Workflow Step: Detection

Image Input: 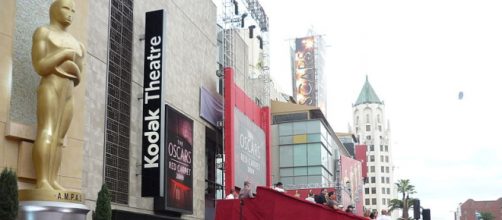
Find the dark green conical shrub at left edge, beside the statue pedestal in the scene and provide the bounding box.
[0,169,19,220]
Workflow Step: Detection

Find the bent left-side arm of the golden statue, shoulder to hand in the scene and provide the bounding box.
[31,27,76,76]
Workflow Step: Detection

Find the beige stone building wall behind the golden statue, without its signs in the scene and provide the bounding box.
[0,0,226,219]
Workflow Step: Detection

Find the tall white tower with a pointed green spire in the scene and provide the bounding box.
[352,76,396,212]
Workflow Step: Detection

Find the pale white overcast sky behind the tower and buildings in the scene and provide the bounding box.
[260,0,502,220]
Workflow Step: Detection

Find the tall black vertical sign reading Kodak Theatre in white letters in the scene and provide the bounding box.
[141,10,165,197]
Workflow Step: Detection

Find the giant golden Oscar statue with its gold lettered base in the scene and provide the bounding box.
[20,0,85,202]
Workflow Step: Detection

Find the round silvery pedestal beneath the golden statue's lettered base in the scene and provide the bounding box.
[18,201,89,220]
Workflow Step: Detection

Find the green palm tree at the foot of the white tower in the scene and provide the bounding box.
[389,179,416,219]
